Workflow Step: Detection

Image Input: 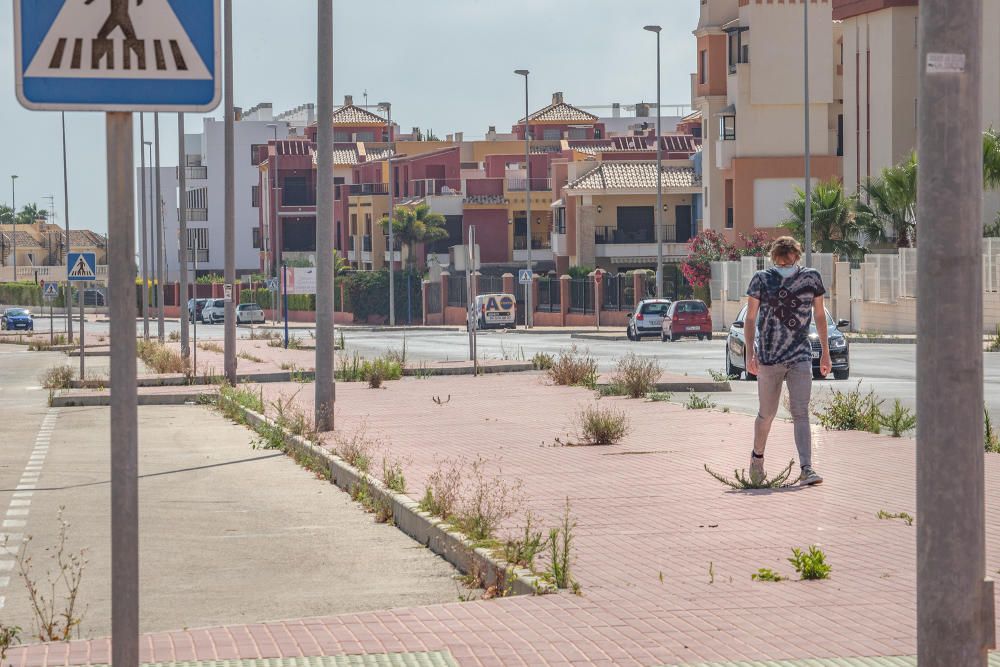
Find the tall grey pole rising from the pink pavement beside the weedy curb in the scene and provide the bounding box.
[315,0,338,432]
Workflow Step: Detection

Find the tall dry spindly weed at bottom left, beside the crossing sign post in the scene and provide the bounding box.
[16,507,88,642]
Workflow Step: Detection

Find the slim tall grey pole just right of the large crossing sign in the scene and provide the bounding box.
[223,0,236,386]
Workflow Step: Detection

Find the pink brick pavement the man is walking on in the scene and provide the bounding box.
[12,374,1000,665]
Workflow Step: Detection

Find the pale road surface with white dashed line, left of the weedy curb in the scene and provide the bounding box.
[0,345,459,641]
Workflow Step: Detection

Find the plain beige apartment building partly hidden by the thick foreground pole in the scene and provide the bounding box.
[833,0,1000,221]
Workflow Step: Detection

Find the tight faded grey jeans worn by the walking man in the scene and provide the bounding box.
[753,361,812,467]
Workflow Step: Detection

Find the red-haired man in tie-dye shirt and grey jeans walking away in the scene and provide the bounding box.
[743,236,833,486]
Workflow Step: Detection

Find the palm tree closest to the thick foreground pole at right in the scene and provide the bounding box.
[857,153,917,248]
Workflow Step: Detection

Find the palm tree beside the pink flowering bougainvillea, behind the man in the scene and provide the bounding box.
[780,178,866,259]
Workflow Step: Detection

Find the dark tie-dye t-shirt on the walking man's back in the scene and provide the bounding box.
[747,267,826,366]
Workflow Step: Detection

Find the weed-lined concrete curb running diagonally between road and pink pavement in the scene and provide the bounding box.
[223,396,556,595]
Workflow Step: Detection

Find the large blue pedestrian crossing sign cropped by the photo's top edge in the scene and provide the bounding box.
[14,0,222,111]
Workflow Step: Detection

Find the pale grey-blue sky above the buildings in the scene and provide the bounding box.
[0,0,698,232]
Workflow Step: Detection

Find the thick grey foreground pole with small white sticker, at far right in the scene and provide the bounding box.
[917,0,996,667]
